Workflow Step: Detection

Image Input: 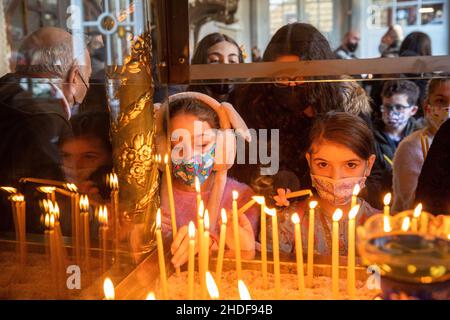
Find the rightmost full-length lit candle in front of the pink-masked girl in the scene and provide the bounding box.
[347,205,360,299]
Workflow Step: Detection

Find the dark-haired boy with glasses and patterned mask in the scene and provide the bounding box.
[374,80,420,201]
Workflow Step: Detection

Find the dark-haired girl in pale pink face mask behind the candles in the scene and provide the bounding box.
[268,112,378,255]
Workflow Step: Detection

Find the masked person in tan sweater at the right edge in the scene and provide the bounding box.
[393,74,450,211]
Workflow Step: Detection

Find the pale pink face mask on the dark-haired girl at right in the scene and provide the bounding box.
[311,174,367,206]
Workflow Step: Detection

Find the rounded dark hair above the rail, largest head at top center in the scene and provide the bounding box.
[263,22,334,62]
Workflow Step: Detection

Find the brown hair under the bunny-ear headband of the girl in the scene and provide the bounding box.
[163,99,220,132]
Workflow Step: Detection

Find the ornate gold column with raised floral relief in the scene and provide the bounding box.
[103,1,159,254]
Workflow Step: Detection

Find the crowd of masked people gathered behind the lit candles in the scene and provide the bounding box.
[0,23,450,266]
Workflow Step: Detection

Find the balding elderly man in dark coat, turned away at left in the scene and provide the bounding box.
[0,27,91,232]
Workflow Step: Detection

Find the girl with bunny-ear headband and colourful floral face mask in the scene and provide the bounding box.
[156,92,259,267]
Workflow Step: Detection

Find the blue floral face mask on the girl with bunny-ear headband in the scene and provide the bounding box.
[172,144,216,187]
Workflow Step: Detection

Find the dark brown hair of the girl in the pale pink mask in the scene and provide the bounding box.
[308,111,375,160]
